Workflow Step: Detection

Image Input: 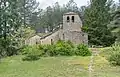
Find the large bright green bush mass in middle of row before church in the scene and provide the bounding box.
[39,41,73,56]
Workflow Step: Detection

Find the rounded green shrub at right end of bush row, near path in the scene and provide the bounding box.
[75,44,92,56]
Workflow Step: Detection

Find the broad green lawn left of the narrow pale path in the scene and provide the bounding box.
[0,56,89,77]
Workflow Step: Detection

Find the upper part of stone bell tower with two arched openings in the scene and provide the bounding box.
[63,12,82,31]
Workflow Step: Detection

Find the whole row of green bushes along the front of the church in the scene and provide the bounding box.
[22,40,91,57]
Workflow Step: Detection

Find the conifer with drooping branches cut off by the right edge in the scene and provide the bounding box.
[108,0,120,42]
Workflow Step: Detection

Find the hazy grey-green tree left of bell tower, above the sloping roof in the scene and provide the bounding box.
[36,2,63,32]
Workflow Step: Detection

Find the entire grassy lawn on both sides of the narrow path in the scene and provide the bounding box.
[0,49,120,77]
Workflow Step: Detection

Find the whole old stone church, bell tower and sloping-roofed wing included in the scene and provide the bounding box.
[25,12,88,45]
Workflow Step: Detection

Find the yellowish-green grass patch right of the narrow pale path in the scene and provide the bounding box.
[93,56,120,77]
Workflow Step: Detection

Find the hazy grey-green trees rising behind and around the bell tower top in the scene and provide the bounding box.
[35,0,84,32]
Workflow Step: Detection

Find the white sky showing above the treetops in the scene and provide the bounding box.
[37,0,118,9]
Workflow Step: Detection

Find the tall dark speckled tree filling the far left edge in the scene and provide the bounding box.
[0,0,21,56]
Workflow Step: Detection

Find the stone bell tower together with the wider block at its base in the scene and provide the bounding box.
[60,12,88,44]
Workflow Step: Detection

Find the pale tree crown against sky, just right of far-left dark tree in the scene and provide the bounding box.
[18,0,39,26]
